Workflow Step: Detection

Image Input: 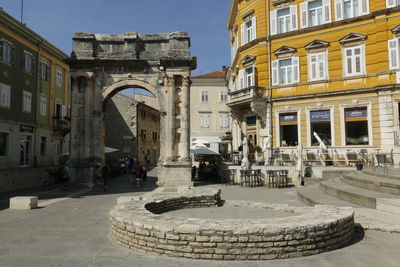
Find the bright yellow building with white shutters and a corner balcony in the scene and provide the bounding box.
[228,0,400,162]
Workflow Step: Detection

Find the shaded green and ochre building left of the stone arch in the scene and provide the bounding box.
[0,10,71,192]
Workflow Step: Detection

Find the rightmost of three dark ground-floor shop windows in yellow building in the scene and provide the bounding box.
[345,108,369,145]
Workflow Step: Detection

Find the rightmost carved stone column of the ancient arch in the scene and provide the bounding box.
[179,76,190,161]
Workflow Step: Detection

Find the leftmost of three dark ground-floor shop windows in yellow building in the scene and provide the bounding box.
[279,113,299,146]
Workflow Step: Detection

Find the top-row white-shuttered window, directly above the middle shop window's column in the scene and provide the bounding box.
[300,0,331,28]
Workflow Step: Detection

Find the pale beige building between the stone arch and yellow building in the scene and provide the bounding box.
[190,71,231,157]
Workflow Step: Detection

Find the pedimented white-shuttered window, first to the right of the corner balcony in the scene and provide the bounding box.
[272,57,300,85]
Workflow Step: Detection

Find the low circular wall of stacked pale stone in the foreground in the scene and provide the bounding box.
[110,188,354,260]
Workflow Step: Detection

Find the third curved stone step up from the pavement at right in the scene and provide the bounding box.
[341,172,400,196]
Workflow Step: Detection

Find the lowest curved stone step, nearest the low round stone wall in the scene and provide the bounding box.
[297,184,362,208]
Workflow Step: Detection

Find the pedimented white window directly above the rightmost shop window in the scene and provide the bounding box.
[343,45,365,77]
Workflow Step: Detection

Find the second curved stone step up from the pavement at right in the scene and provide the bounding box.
[320,178,396,209]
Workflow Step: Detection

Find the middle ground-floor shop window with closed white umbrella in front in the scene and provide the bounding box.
[310,110,332,146]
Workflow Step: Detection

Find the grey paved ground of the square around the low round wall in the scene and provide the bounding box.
[0,169,400,267]
